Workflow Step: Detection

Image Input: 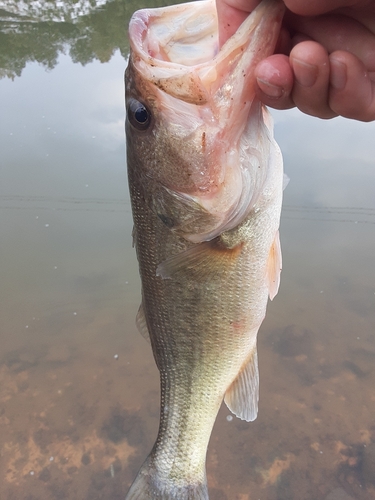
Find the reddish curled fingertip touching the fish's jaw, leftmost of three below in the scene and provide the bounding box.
[255,54,294,109]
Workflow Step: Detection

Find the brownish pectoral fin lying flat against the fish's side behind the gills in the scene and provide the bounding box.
[156,237,243,279]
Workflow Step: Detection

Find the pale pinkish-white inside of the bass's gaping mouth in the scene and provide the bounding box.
[129,0,219,66]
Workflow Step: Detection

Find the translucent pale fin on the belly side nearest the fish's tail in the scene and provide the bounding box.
[224,345,259,422]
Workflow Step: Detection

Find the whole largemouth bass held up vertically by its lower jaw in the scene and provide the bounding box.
[125,0,284,500]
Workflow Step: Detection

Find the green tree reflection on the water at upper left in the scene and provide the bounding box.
[0,0,175,79]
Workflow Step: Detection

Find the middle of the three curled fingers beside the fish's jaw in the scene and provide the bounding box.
[290,41,336,118]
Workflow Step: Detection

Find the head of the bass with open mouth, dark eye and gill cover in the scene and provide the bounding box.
[125,0,283,242]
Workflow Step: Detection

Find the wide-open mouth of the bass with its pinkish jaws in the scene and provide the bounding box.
[129,0,284,107]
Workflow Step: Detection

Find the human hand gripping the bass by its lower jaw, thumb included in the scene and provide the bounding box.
[216,0,375,121]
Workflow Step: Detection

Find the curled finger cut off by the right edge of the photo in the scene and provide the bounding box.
[329,51,375,121]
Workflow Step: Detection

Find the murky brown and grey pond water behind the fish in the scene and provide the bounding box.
[0,0,375,500]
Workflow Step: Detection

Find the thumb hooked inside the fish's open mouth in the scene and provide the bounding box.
[216,0,260,47]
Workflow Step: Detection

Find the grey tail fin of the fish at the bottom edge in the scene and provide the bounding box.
[125,458,209,500]
